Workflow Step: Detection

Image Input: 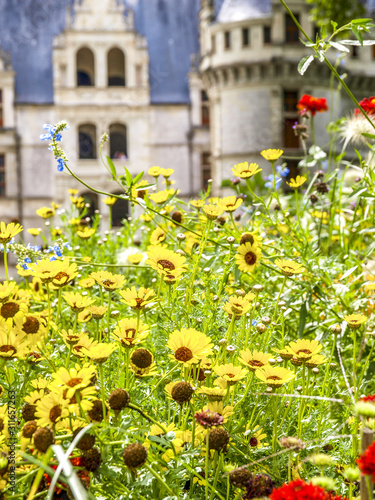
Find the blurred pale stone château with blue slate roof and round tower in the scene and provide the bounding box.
[0,0,375,227]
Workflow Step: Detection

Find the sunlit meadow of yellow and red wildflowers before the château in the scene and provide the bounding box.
[0,6,375,500]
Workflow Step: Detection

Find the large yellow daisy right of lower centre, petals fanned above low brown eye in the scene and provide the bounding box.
[167,328,213,367]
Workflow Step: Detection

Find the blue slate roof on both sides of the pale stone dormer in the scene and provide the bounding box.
[0,0,200,104]
